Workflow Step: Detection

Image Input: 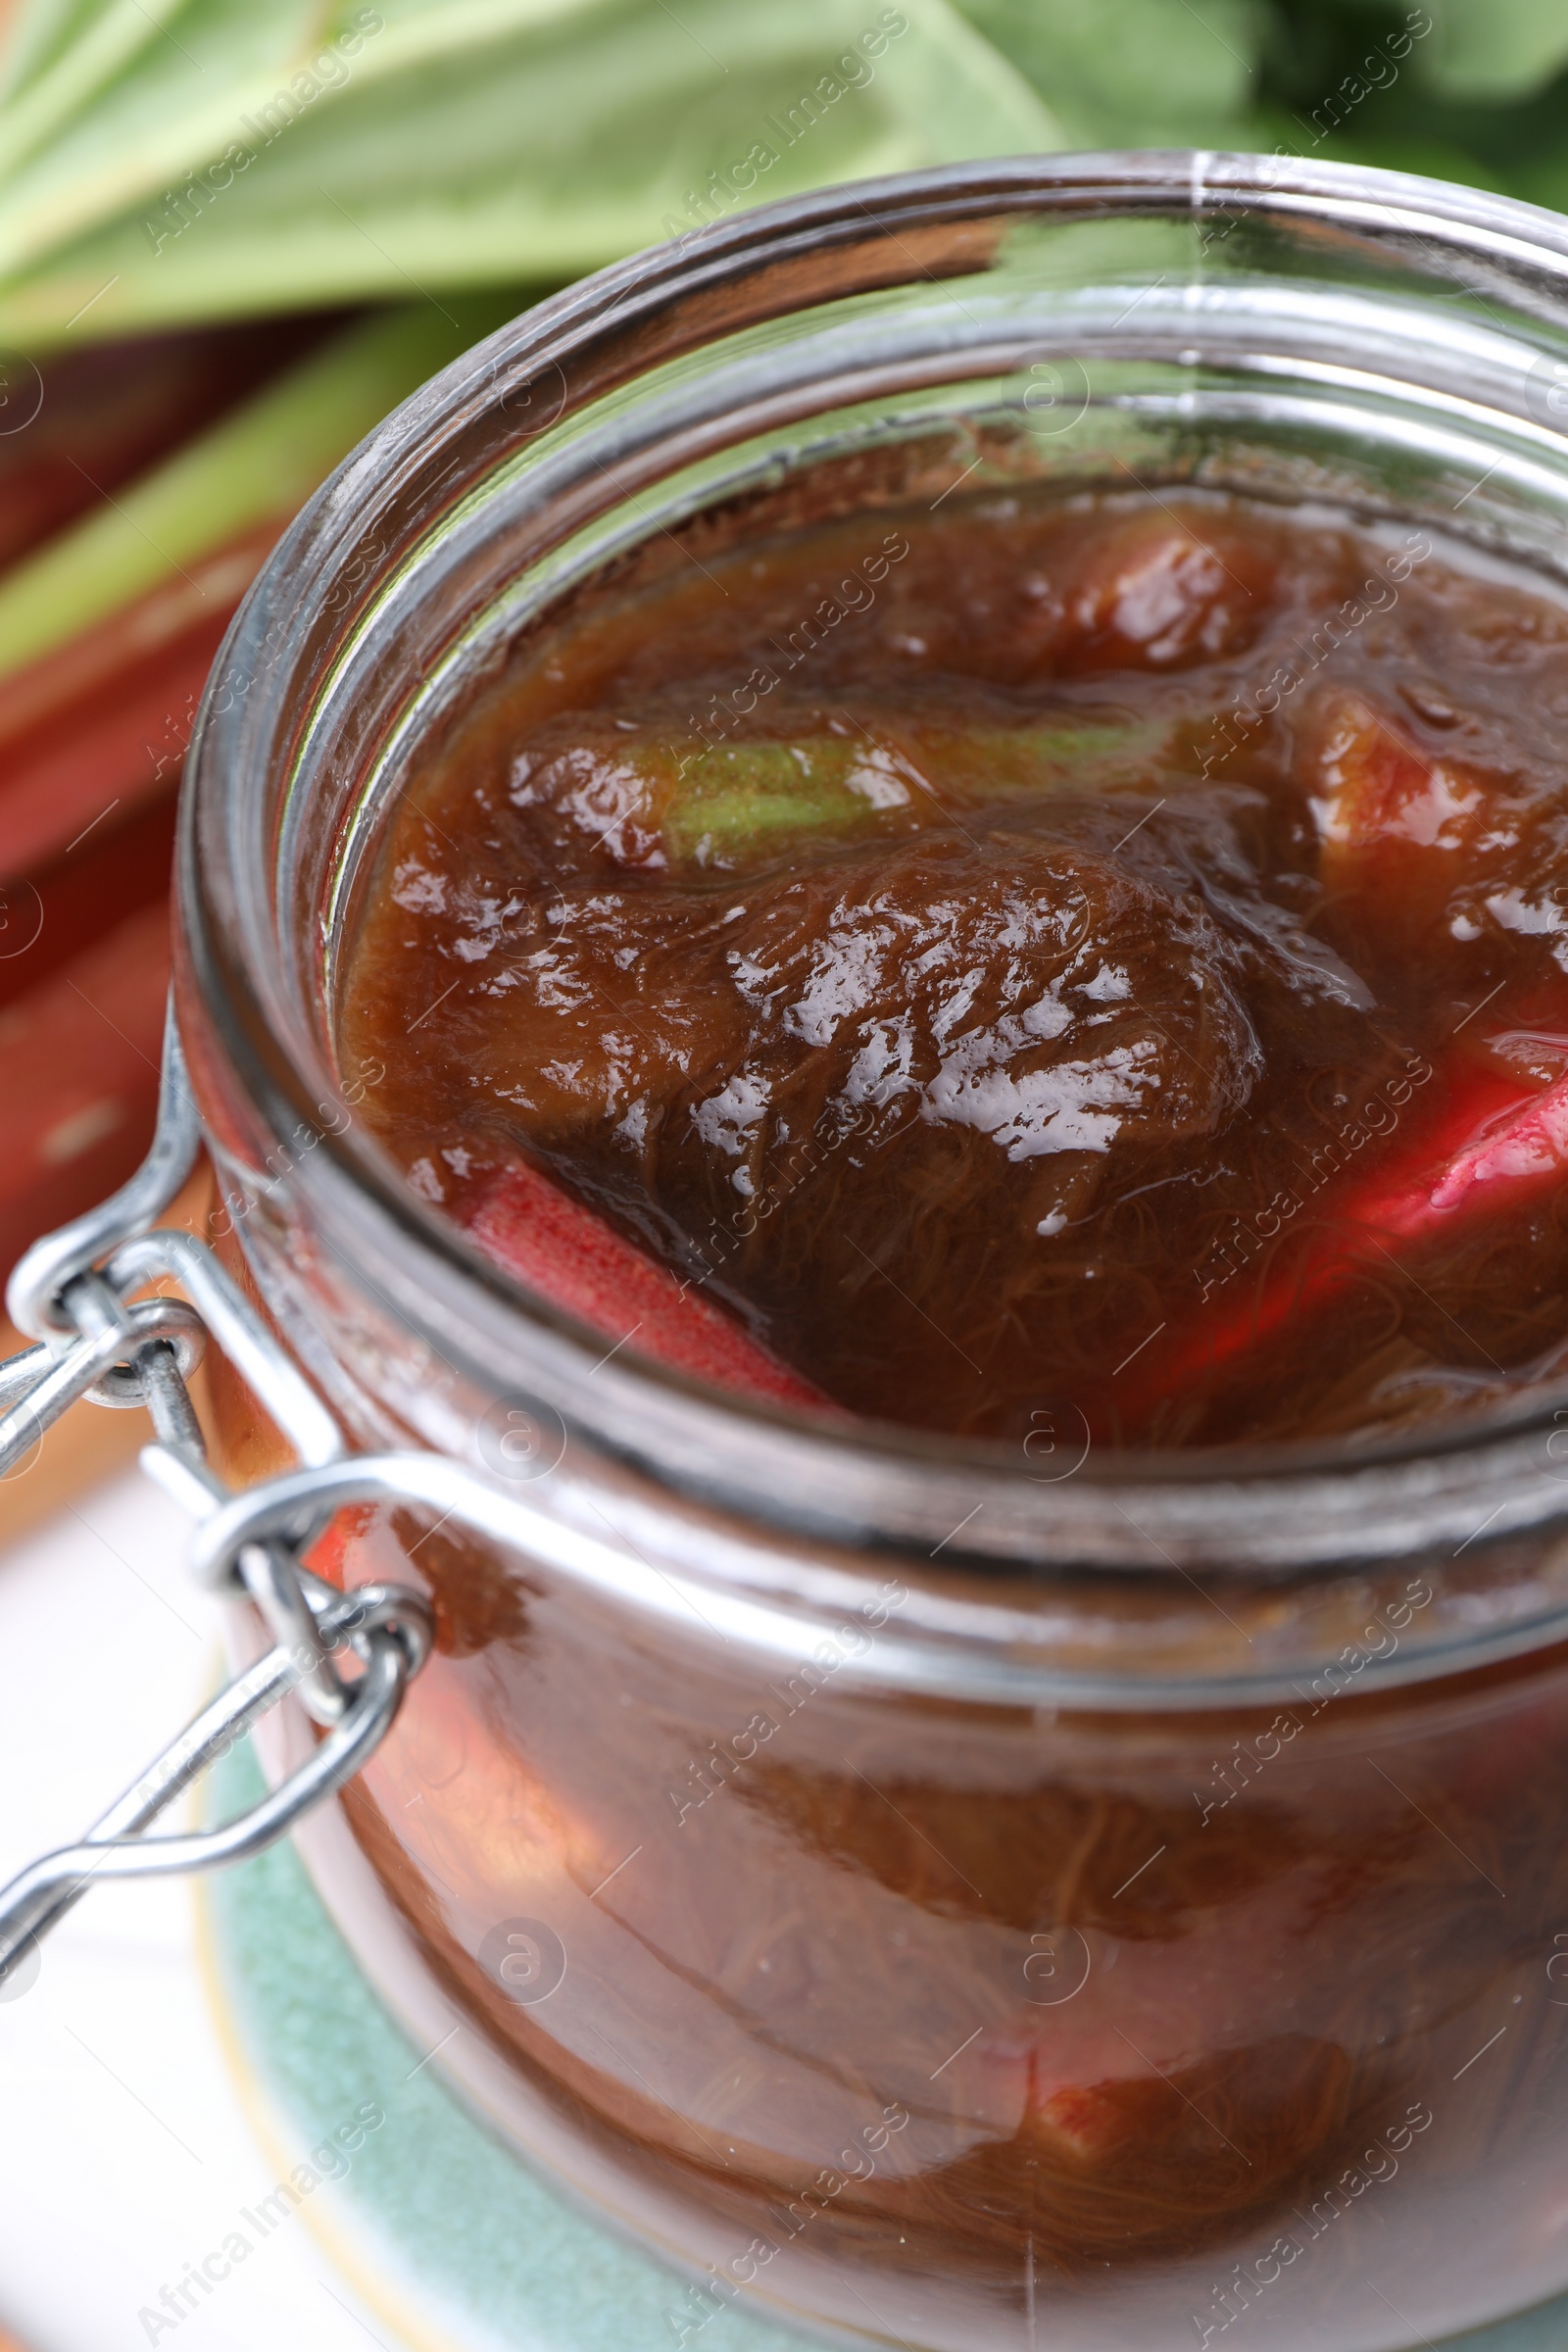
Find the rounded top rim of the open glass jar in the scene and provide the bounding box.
[176,151,1568,1574]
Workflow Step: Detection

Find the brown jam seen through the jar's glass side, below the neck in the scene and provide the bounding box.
[291,1517,1568,2352]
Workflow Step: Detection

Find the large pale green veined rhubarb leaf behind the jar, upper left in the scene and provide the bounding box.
[0,0,1065,346]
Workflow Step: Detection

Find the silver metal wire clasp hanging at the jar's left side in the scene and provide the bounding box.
[0,1011,432,1978]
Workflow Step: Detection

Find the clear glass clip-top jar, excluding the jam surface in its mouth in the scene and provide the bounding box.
[178,155,1568,2352]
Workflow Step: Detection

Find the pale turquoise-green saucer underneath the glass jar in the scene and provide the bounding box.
[202,1750,1568,2352]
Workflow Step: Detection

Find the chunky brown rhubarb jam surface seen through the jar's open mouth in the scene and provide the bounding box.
[341,492,1568,1446]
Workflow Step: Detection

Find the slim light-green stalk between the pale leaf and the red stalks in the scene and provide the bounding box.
[0,299,511,675]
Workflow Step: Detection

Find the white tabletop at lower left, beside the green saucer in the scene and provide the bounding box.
[0,1472,411,2352]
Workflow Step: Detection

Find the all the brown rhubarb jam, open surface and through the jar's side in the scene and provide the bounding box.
[322,489,1568,2352]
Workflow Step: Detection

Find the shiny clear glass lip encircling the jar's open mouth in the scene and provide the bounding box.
[176,151,1568,1564]
